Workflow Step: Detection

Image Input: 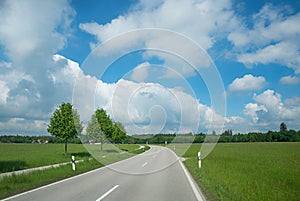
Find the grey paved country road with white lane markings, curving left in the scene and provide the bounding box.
[5,146,204,201]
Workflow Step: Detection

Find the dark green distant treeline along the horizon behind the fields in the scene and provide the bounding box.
[0,130,300,144]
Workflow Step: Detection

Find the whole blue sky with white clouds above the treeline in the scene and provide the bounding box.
[0,0,300,135]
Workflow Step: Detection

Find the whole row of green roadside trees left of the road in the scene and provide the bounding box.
[47,103,126,154]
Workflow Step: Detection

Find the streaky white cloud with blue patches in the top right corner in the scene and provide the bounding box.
[228,4,300,74]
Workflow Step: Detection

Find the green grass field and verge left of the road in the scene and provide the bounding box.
[0,144,149,199]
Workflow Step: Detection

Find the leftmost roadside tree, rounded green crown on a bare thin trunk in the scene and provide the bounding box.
[47,103,83,155]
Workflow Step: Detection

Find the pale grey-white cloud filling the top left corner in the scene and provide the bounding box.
[0,0,74,61]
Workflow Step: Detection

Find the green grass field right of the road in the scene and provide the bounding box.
[176,143,300,201]
